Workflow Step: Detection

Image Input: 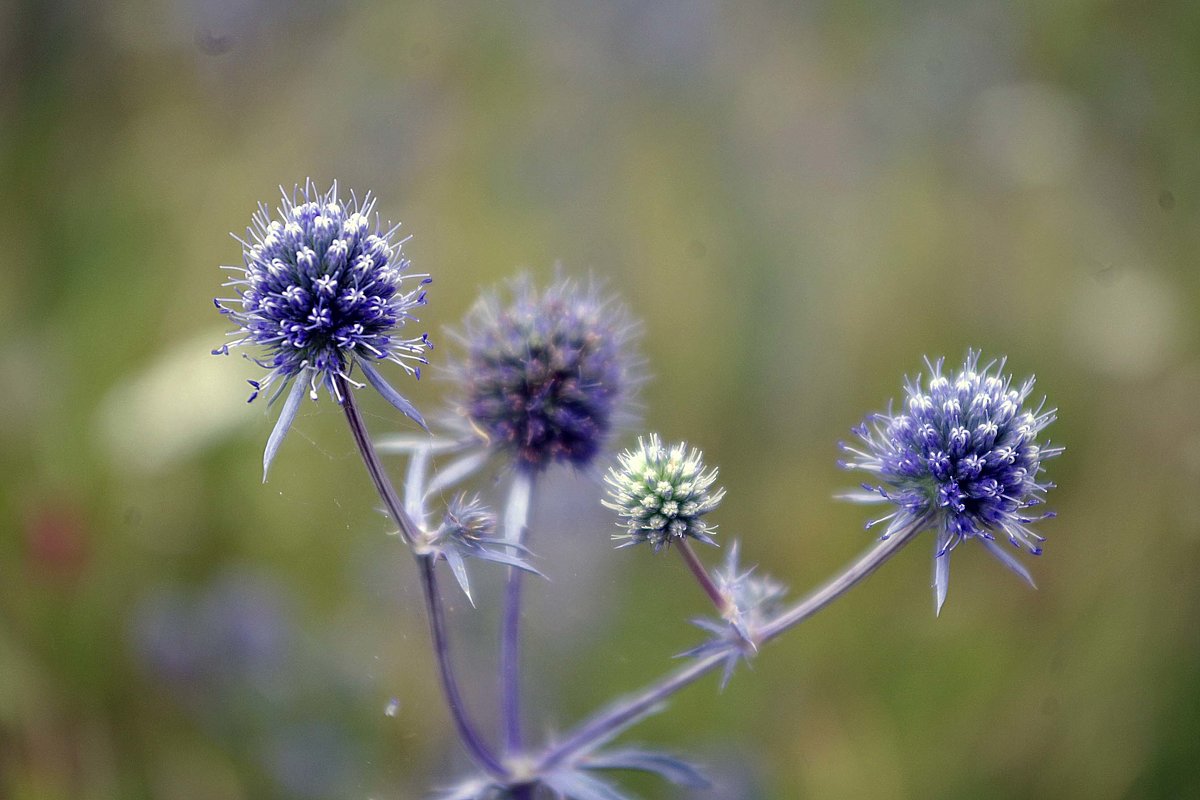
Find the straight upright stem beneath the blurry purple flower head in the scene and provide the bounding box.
[500,471,534,753]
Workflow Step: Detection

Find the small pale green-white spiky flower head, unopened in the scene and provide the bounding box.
[601,433,725,553]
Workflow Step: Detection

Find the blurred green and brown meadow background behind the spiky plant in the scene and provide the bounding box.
[0,0,1200,800]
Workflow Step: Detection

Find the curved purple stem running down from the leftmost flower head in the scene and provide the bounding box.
[335,375,508,777]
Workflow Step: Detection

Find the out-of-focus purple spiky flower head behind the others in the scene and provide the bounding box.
[455,277,640,471]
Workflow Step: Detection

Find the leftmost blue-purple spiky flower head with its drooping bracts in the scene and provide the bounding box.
[212,181,432,481]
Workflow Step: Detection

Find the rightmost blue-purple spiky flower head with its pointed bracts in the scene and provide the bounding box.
[841,350,1063,612]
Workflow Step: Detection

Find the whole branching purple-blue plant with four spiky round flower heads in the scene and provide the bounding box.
[214,182,1063,800]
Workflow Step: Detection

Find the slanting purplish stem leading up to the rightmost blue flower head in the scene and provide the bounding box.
[538,518,925,770]
